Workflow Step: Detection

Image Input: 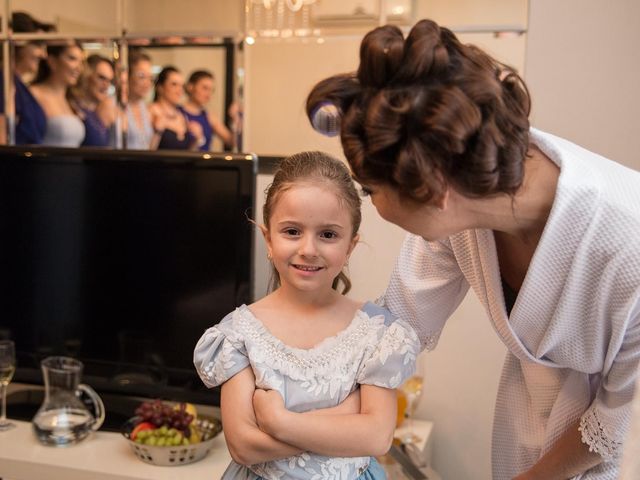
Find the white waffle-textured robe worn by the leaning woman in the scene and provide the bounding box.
[384,129,640,480]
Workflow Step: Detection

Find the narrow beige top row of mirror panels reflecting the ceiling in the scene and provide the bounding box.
[10,0,527,36]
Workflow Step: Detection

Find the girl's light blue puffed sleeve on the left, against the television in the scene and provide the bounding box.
[193,312,249,388]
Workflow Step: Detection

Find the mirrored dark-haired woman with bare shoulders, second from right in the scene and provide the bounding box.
[149,66,204,150]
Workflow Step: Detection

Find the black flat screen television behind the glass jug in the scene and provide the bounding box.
[0,147,257,429]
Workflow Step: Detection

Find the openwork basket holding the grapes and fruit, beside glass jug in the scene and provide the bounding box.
[122,417,222,466]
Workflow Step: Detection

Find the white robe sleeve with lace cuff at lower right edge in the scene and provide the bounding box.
[580,301,640,460]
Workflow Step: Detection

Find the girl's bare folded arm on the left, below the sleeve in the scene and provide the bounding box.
[220,367,302,465]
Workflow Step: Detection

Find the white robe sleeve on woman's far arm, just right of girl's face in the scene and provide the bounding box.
[383,234,469,350]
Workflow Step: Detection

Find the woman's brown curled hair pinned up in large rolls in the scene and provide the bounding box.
[307,20,530,203]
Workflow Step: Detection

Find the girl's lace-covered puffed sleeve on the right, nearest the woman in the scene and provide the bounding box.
[356,312,420,388]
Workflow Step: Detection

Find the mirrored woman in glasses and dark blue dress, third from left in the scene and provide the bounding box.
[73,55,116,147]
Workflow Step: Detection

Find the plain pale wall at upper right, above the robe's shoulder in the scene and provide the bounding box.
[525,0,640,169]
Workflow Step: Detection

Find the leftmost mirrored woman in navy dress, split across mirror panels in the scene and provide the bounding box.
[0,12,54,145]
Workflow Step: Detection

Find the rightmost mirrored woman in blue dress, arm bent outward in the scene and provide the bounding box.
[180,70,235,151]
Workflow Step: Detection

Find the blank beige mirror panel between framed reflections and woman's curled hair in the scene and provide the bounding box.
[245,37,360,157]
